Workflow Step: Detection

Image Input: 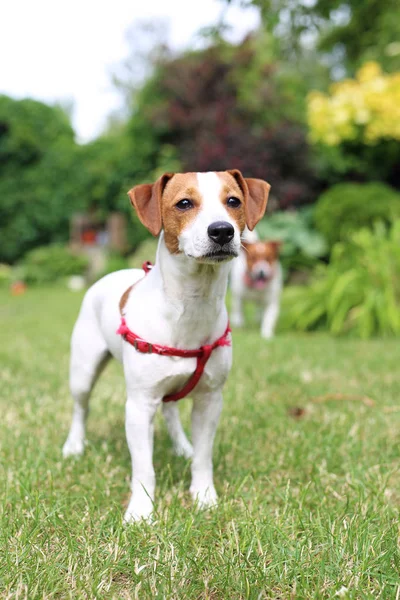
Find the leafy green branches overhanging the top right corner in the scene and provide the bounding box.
[221,0,400,75]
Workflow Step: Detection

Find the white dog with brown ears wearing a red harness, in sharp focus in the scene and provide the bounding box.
[63,170,270,522]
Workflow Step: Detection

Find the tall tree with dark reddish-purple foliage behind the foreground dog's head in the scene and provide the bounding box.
[128,38,315,206]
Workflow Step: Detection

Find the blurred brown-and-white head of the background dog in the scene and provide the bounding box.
[243,241,282,289]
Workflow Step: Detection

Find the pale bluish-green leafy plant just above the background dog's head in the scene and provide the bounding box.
[257,207,327,271]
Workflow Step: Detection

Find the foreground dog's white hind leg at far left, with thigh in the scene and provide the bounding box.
[63,310,110,458]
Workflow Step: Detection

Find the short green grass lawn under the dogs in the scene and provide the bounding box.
[0,289,400,600]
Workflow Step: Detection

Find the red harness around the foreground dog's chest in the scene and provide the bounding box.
[117,262,231,402]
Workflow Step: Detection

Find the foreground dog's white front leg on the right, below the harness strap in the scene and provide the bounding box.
[190,390,222,507]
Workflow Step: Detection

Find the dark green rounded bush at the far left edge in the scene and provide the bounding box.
[0,96,76,262]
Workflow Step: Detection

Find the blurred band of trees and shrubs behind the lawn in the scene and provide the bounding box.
[0,0,400,337]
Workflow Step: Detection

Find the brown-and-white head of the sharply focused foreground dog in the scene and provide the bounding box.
[129,169,270,263]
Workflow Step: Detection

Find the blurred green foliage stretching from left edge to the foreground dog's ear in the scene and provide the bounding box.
[0,96,170,263]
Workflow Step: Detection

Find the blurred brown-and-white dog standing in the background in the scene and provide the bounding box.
[231,231,283,339]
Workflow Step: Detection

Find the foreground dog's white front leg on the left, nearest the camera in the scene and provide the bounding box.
[124,394,159,523]
